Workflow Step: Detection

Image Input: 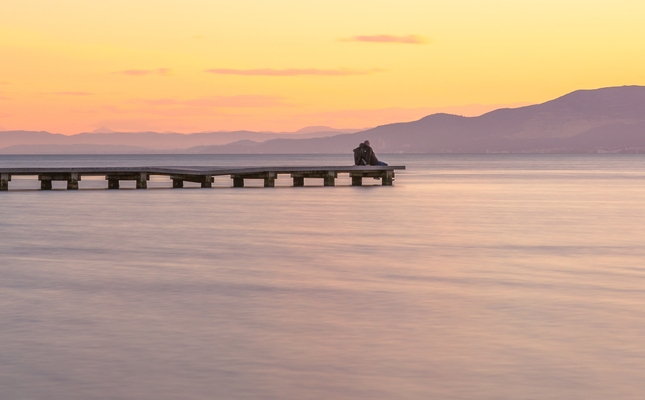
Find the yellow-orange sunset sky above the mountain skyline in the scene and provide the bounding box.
[0,0,645,134]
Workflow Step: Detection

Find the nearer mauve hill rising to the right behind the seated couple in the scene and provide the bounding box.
[189,86,645,153]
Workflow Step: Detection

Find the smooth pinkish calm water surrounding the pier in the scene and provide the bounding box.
[0,155,645,400]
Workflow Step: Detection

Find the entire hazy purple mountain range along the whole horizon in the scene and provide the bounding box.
[0,86,645,154]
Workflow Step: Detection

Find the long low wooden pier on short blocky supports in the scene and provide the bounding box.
[0,166,405,191]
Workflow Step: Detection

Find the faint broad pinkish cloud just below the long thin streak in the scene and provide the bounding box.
[138,95,288,108]
